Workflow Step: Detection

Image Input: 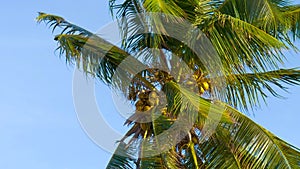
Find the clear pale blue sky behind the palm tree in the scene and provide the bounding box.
[0,0,300,169]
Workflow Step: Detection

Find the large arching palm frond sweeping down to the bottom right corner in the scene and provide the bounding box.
[158,82,300,168]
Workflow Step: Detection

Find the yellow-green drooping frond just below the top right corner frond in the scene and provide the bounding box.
[208,11,286,73]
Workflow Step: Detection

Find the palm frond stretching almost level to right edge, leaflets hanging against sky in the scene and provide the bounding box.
[217,69,300,108]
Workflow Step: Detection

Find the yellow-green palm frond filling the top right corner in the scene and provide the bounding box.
[218,0,299,49]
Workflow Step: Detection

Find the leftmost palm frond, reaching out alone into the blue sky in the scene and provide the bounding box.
[37,13,153,89]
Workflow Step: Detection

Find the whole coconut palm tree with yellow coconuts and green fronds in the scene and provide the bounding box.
[37,0,300,169]
